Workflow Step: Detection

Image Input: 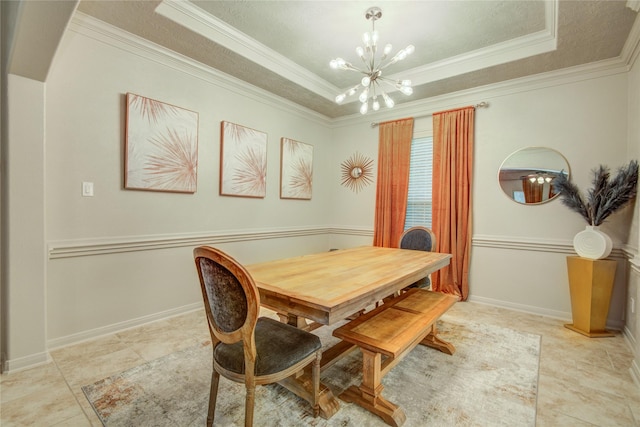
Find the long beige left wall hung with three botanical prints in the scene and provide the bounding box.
[46,23,333,346]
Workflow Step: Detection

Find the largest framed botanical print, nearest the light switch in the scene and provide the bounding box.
[124,93,198,193]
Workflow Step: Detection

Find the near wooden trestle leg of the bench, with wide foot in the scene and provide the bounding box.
[339,349,407,427]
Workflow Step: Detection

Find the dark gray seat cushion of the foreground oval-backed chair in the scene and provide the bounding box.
[213,317,321,376]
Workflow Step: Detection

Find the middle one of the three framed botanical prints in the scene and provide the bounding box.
[220,121,267,197]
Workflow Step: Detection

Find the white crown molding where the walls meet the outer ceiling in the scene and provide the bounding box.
[69,7,640,128]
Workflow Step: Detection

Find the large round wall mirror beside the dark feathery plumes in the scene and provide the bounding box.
[498,147,569,205]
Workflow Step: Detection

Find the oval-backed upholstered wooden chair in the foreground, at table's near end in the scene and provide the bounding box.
[193,246,322,426]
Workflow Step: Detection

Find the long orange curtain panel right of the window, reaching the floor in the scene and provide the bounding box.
[431,107,475,301]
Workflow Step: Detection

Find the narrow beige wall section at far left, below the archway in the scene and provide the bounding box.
[3,75,48,366]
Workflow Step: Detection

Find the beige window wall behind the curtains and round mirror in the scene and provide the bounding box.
[334,72,628,322]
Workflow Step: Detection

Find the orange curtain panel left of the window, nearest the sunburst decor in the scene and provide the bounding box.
[373,118,413,248]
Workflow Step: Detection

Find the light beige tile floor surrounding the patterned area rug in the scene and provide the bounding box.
[0,302,640,427]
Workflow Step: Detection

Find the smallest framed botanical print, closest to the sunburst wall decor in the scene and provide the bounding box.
[280,138,313,200]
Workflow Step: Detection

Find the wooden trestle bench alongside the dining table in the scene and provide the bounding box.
[333,289,458,426]
